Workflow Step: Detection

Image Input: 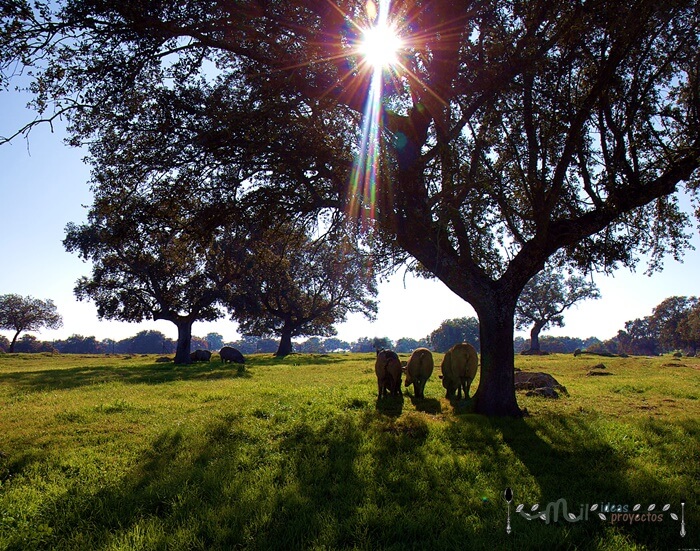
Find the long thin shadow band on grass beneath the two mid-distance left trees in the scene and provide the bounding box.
[0,362,252,391]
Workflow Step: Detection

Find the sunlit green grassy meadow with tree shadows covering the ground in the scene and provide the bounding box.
[0,354,700,551]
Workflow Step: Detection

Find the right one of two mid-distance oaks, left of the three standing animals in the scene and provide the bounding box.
[231,224,377,356]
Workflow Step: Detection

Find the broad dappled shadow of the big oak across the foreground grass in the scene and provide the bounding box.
[9,409,697,551]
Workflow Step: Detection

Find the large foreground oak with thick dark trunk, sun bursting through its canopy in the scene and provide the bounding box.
[0,0,700,415]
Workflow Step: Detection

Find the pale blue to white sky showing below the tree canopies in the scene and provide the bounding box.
[0,91,700,350]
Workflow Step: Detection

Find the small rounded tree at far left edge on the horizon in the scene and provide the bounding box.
[0,294,63,352]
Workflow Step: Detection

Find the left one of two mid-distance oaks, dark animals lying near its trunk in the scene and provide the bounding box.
[63,185,248,364]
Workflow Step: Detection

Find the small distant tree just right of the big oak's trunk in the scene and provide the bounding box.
[515,267,600,352]
